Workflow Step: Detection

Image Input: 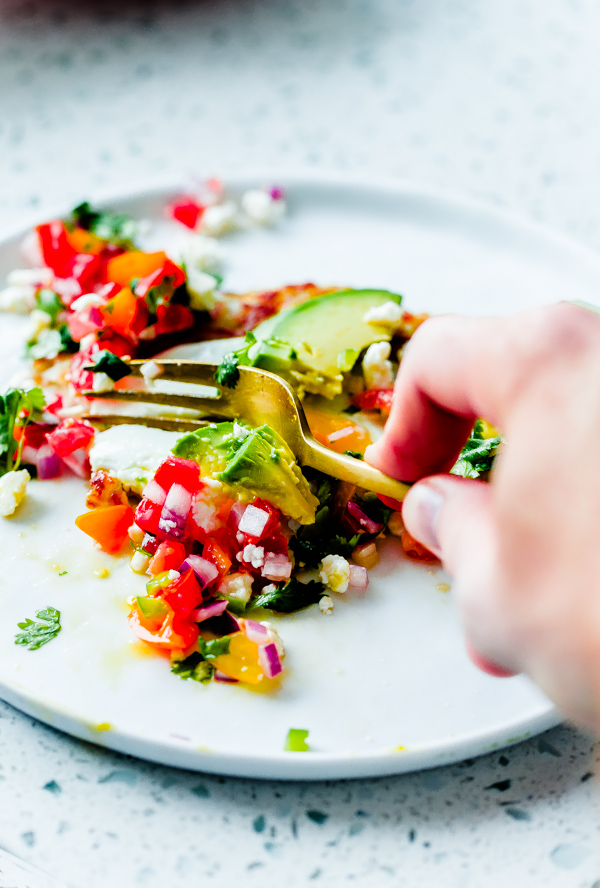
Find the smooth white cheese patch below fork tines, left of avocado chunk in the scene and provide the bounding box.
[90,425,181,496]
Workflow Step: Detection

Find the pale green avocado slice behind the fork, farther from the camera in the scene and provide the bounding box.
[253,290,402,375]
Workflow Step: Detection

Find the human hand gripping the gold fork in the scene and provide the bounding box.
[366,303,600,732]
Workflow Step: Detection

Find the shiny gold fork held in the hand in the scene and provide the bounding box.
[83,358,410,500]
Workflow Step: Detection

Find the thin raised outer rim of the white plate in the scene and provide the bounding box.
[0,168,576,780]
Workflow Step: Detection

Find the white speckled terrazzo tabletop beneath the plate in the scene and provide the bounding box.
[0,0,600,888]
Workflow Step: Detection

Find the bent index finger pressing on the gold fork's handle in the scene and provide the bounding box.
[366,304,600,481]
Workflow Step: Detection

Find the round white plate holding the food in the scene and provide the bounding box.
[0,170,600,779]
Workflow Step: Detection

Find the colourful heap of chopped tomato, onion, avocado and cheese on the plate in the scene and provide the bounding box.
[0,180,500,685]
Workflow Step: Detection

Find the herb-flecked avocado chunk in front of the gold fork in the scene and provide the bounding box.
[173,422,319,524]
